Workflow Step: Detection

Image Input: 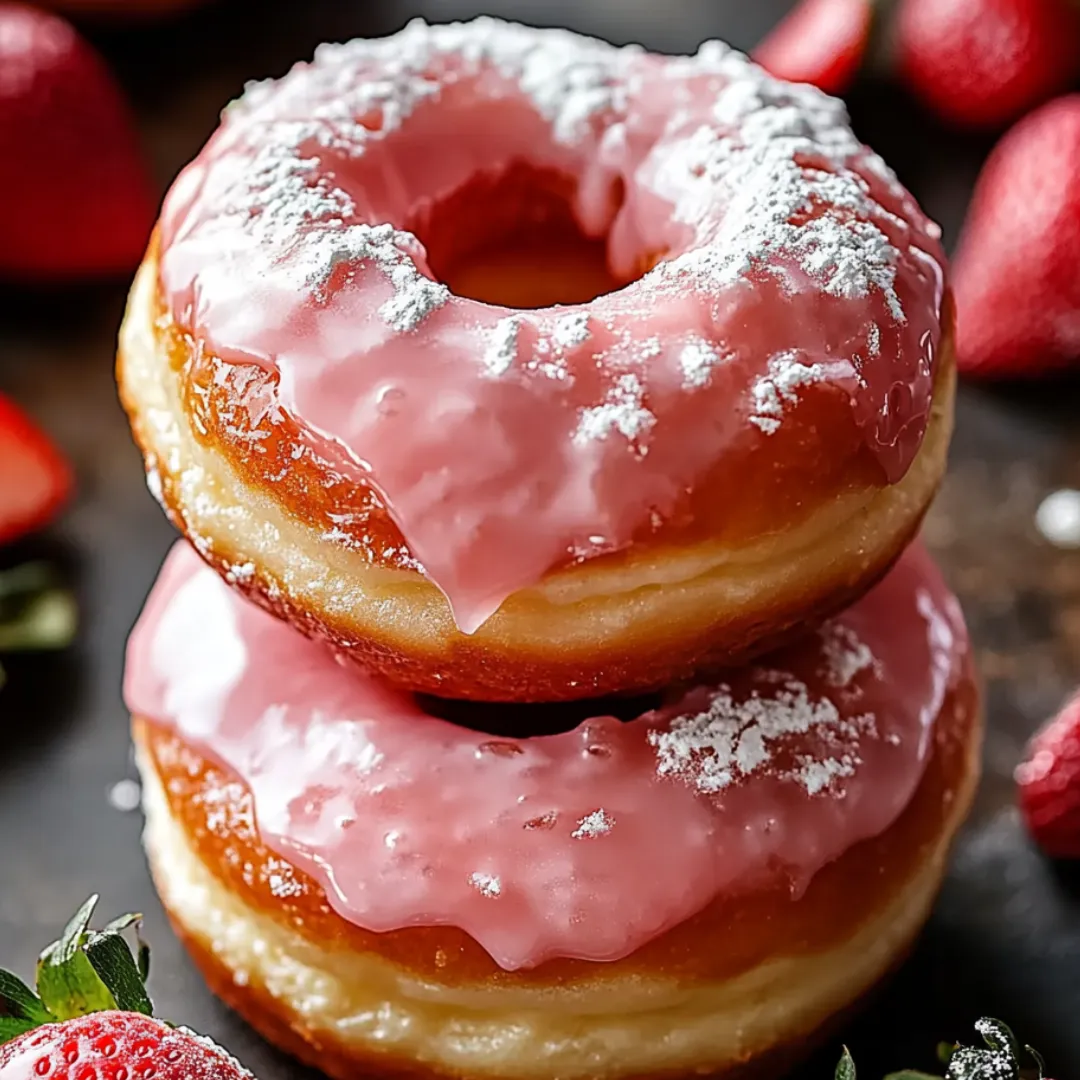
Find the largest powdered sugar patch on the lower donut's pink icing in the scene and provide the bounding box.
[649,671,873,795]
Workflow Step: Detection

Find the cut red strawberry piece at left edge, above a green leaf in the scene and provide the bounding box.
[0,395,71,543]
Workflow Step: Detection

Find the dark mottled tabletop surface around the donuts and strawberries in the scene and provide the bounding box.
[0,0,1080,1080]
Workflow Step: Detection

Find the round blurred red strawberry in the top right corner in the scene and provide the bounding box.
[895,0,1080,127]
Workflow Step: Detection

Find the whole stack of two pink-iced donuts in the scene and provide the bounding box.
[119,19,980,1080]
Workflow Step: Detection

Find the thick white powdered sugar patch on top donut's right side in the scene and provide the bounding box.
[660,48,905,322]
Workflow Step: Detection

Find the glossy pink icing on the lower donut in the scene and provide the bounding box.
[125,545,968,970]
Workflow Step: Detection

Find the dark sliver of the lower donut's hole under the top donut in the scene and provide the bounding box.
[417,693,663,739]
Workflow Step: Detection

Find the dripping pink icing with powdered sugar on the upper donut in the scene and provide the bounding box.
[160,19,943,632]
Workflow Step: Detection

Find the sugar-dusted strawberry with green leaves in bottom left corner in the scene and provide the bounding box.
[0,897,251,1080]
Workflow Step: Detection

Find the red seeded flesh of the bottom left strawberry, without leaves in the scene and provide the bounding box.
[0,1012,251,1080]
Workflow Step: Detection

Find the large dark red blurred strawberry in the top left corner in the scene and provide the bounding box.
[0,2,154,279]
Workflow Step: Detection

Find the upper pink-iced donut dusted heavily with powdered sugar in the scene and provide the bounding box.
[119,18,955,702]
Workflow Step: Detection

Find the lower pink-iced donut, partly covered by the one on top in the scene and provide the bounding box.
[125,543,981,1080]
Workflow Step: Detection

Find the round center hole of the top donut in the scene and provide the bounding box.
[408,164,633,309]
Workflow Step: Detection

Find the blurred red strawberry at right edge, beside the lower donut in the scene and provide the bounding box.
[1016,693,1080,859]
